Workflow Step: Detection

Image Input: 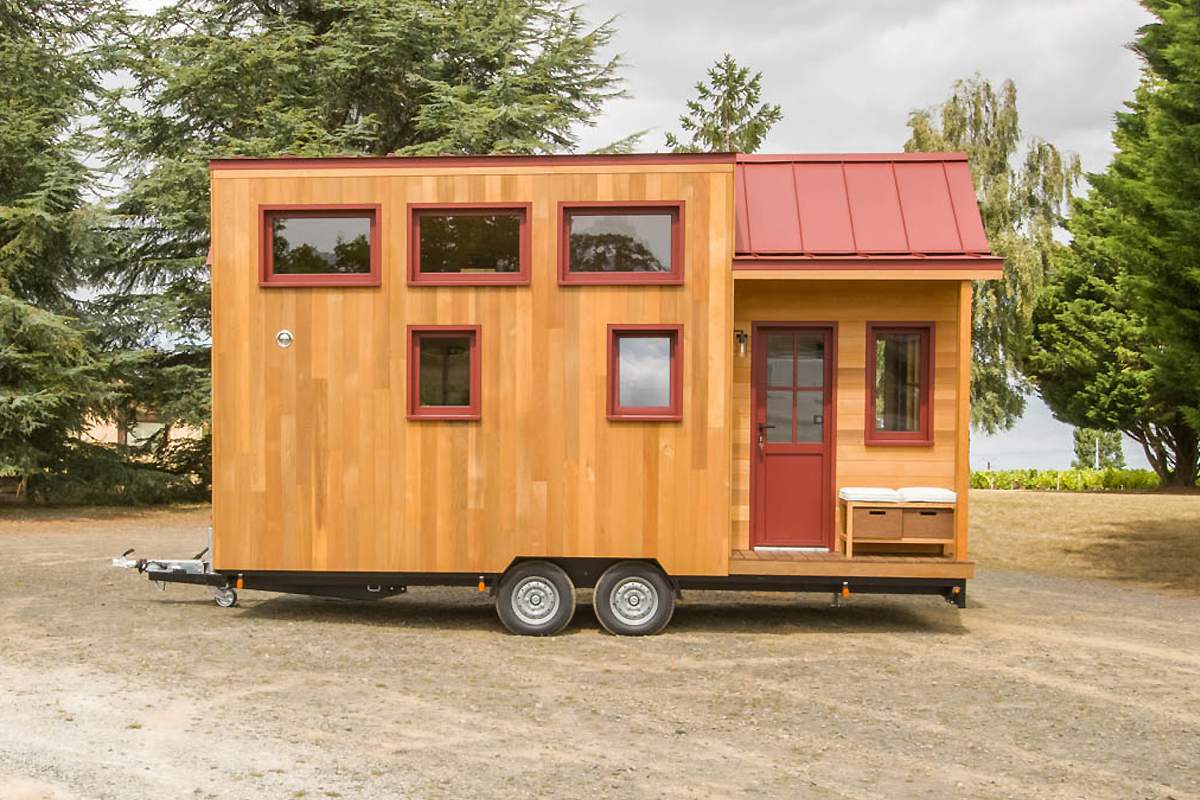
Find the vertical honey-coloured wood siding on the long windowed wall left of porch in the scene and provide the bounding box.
[212,163,734,575]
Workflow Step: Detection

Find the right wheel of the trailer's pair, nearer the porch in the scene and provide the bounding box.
[592,561,674,636]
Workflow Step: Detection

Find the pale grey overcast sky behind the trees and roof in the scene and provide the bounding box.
[581,0,1150,469]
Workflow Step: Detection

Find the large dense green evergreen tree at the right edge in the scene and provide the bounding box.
[1030,0,1200,487]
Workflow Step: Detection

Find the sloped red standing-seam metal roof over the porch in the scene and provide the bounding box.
[734,152,990,260]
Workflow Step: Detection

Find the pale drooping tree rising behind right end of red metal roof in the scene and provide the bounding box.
[905,76,1081,433]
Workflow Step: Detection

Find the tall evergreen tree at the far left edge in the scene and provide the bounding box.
[0,0,115,476]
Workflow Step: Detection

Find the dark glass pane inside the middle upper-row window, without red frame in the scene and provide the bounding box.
[418,212,521,273]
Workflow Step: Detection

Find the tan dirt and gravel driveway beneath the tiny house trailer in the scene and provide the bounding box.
[0,509,1200,800]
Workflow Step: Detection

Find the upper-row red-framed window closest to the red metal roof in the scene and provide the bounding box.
[558,203,683,284]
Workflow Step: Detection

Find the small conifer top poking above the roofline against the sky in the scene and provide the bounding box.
[667,53,784,152]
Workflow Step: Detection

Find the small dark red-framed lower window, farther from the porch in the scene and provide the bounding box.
[408,325,480,420]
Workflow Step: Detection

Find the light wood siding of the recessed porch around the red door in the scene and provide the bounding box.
[731,279,970,551]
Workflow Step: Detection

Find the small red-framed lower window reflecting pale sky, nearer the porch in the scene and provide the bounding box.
[608,325,683,421]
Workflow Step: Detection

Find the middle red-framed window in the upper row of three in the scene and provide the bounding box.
[408,204,529,285]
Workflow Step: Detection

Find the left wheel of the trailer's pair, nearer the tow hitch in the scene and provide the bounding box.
[496,561,575,636]
